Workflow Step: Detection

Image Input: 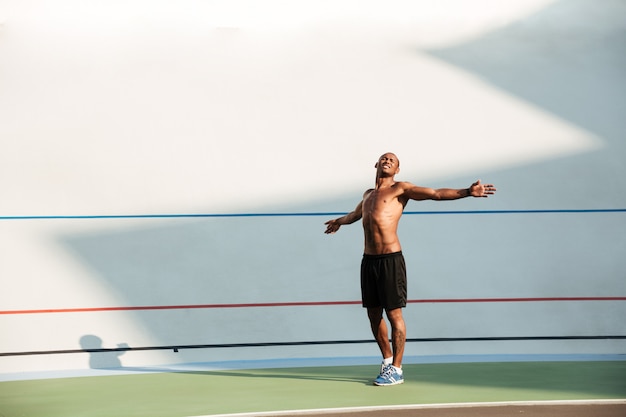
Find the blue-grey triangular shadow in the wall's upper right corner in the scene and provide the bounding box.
[428,0,626,141]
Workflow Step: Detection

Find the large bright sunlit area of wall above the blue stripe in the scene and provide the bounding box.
[0,0,600,215]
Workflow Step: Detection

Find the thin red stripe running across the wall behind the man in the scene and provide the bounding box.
[0,297,626,315]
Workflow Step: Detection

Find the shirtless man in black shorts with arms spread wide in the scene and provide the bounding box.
[325,153,496,386]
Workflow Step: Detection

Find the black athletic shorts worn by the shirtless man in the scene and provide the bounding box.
[361,252,406,310]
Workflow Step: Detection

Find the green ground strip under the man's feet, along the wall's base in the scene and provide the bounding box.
[0,361,626,417]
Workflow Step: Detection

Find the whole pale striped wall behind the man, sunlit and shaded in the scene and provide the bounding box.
[0,0,626,372]
